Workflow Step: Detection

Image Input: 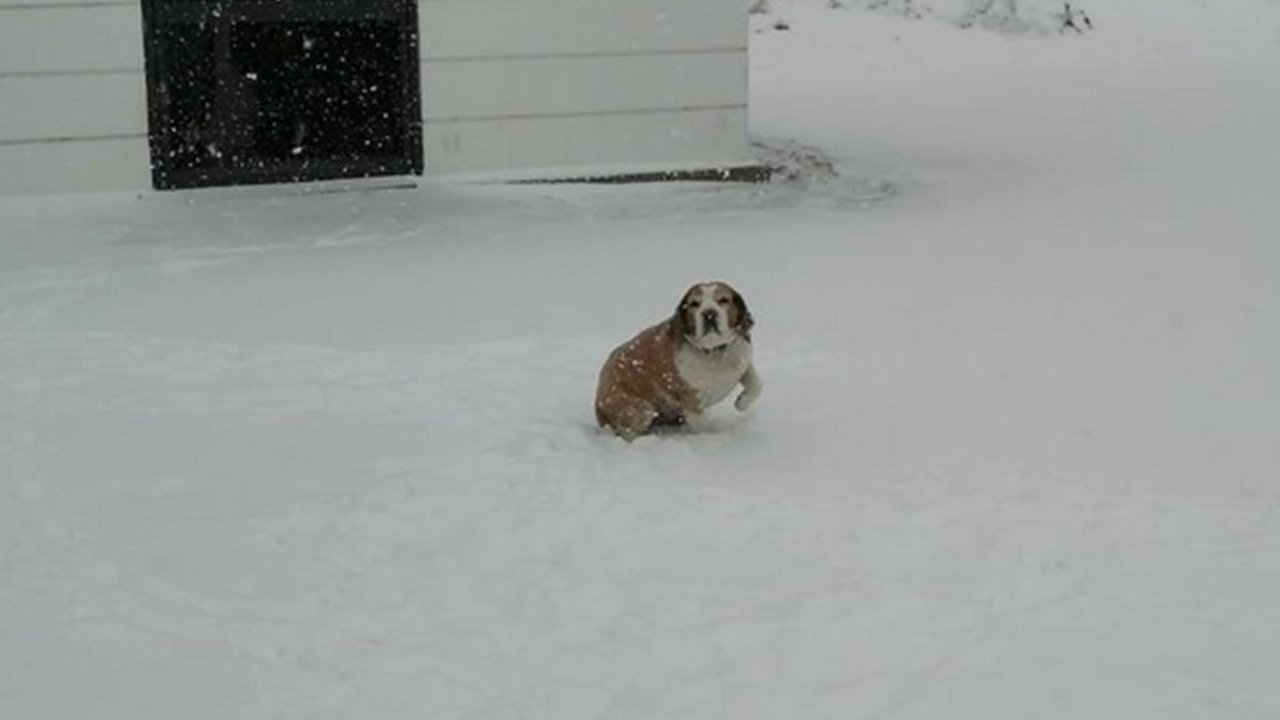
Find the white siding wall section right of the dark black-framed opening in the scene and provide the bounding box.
[419,0,749,174]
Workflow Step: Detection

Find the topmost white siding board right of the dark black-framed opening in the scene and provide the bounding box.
[417,0,748,59]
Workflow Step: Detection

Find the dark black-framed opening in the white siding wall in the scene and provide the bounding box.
[142,0,422,190]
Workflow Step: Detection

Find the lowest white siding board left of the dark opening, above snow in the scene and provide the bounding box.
[0,137,151,195]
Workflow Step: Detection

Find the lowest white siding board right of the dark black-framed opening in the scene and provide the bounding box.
[422,108,750,176]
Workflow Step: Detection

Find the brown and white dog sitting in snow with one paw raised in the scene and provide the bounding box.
[595,282,762,441]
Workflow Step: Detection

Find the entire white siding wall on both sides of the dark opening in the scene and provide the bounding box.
[0,0,749,193]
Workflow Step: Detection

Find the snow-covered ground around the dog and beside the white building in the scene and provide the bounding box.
[0,0,1280,720]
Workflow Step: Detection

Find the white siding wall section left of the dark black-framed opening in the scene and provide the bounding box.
[0,0,151,193]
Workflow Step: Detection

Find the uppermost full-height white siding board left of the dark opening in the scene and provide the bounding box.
[0,3,143,76]
